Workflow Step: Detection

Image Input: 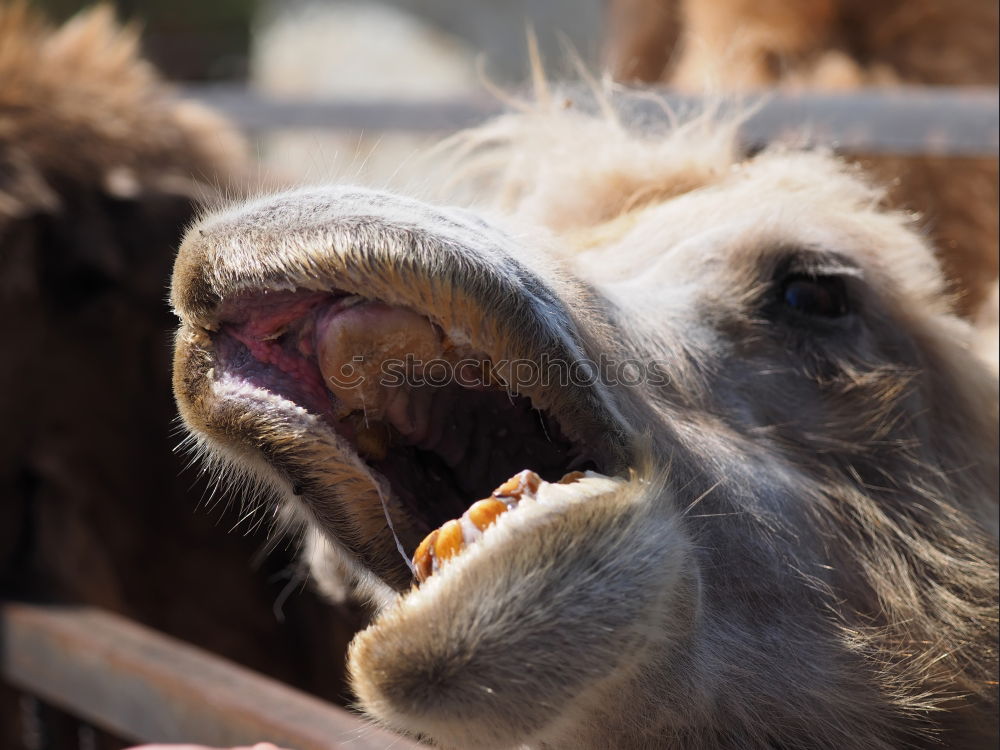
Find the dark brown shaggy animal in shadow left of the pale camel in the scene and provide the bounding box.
[0,3,361,712]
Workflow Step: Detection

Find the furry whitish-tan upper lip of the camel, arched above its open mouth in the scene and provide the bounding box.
[171,187,629,456]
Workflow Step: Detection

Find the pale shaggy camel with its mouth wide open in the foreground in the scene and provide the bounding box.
[172,95,998,750]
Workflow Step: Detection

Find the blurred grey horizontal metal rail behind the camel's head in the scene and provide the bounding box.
[183,86,1000,157]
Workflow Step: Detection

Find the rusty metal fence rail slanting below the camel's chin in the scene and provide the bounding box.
[0,604,418,750]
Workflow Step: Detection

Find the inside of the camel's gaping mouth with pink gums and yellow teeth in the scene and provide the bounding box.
[212,290,613,585]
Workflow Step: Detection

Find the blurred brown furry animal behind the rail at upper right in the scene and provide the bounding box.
[609,0,1000,317]
